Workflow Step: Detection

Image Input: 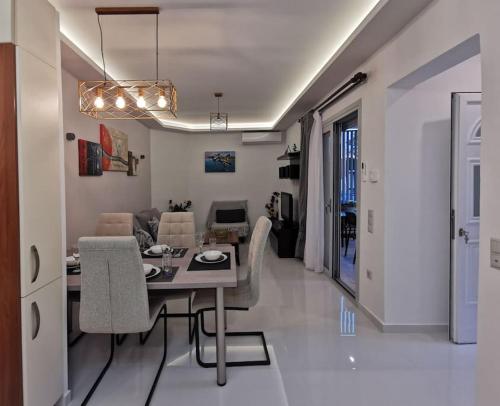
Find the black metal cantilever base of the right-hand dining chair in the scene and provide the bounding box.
[194,307,271,368]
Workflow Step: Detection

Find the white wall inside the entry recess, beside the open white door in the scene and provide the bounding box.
[385,56,481,325]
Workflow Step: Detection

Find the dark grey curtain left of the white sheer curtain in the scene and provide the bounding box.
[295,111,314,259]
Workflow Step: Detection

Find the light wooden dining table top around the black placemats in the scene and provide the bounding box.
[67,245,238,291]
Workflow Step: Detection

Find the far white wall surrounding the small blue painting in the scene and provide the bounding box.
[151,130,285,229]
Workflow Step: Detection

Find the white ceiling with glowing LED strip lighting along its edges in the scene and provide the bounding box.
[51,0,430,131]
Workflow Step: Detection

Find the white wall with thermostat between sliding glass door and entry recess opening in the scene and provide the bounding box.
[292,0,490,324]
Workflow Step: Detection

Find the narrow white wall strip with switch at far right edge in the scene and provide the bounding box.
[477,0,500,406]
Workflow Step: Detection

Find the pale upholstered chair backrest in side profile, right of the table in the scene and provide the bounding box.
[248,216,272,304]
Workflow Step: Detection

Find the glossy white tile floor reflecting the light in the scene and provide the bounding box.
[70,247,476,406]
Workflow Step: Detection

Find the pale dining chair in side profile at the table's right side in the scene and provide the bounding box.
[193,216,271,368]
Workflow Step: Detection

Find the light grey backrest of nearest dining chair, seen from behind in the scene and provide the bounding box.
[78,237,149,334]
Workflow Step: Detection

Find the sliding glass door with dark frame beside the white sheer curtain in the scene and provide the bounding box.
[323,110,360,297]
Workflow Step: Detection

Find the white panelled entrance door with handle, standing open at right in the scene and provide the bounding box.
[450,93,481,344]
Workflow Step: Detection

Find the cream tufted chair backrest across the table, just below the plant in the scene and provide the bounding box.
[157,212,195,248]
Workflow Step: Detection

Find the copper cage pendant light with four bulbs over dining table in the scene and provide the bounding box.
[78,7,177,120]
